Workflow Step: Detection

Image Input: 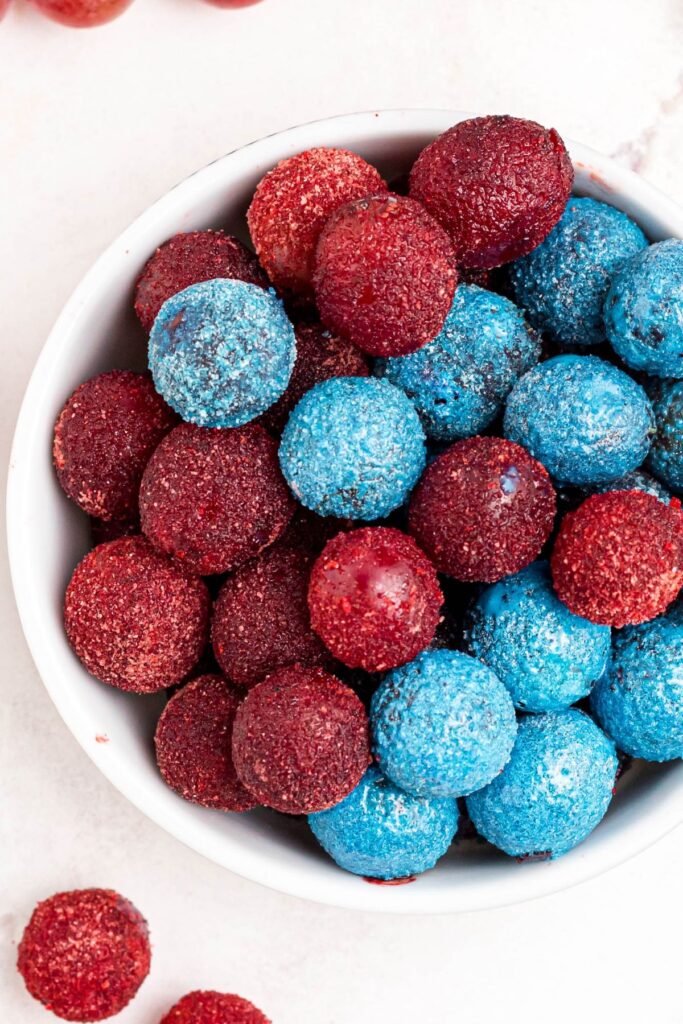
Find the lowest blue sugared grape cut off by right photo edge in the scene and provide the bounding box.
[591,607,683,761]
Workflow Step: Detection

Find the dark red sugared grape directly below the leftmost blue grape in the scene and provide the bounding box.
[140,423,294,575]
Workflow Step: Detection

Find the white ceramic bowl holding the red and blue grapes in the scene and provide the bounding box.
[7,111,683,912]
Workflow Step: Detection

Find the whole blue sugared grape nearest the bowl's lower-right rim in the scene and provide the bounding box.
[467,708,617,859]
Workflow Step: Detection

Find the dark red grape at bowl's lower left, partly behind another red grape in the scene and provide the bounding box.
[155,676,255,811]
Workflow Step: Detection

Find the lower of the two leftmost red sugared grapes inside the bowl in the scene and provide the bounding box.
[65,537,209,693]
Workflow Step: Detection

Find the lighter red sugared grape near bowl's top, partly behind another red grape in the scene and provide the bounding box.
[247,148,386,297]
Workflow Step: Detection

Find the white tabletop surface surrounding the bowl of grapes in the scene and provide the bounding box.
[0,0,683,1024]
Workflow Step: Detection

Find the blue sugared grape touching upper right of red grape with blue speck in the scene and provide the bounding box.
[504,354,654,485]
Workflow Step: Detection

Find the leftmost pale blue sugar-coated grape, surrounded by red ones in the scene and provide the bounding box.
[148,278,296,427]
